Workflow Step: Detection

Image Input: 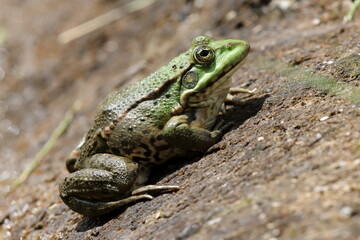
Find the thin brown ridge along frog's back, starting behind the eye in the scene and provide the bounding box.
[98,62,194,141]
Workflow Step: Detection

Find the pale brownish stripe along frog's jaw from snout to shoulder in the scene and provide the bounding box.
[178,59,245,108]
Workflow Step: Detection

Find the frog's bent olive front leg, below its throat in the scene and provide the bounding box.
[163,115,223,151]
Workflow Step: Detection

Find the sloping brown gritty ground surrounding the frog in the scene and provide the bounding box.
[0,0,360,239]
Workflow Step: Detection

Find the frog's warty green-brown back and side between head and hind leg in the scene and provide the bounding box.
[79,51,190,165]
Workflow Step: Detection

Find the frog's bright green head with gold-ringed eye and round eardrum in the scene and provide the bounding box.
[180,36,250,108]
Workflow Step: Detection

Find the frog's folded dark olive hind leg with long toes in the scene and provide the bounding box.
[60,153,180,216]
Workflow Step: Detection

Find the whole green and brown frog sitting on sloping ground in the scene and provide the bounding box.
[59,35,254,217]
